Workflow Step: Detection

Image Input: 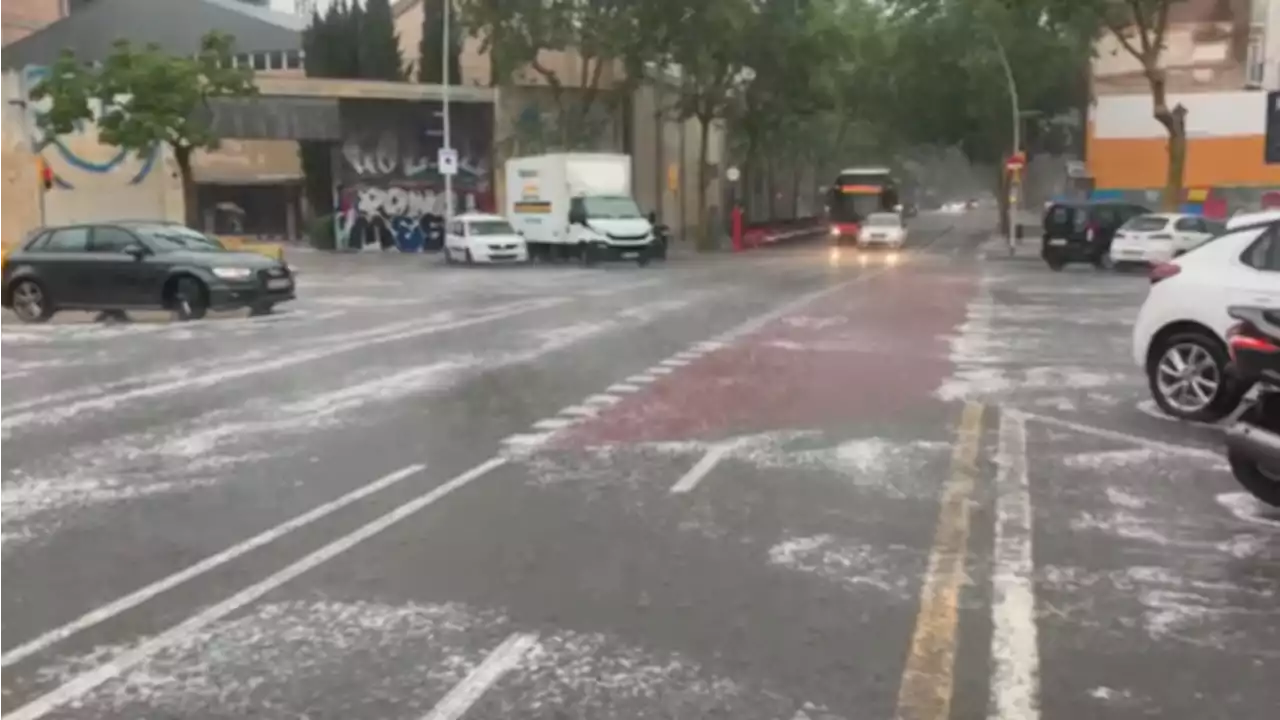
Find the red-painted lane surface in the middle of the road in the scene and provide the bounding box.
[554,266,978,447]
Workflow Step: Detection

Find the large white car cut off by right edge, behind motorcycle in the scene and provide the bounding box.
[1133,217,1280,421]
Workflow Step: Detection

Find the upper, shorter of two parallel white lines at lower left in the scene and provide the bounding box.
[0,465,426,670]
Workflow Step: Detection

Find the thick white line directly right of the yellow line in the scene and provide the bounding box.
[987,413,1039,720]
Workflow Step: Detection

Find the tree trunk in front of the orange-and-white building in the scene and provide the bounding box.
[1053,0,1182,210]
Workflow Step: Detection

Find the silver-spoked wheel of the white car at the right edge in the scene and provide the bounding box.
[1147,332,1248,423]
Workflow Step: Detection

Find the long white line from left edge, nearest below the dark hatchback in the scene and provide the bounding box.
[0,299,567,430]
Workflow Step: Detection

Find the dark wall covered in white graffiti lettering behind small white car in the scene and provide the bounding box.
[334,100,494,252]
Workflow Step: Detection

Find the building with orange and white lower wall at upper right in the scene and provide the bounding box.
[1087,0,1280,214]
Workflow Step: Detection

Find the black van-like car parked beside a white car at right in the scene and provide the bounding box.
[1041,200,1151,270]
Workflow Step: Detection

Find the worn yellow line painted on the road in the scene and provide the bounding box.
[895,402,983,720]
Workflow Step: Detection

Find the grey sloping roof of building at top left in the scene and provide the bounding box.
[0,0,306,68]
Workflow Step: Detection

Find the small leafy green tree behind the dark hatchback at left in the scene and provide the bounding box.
[32,32,257,225]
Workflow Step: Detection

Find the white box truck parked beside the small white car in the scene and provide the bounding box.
[507,152,657,265]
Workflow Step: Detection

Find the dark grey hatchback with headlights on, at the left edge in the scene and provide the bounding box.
[0,222,294,323]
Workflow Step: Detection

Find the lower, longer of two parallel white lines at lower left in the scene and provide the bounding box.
[5,457,507,720]
